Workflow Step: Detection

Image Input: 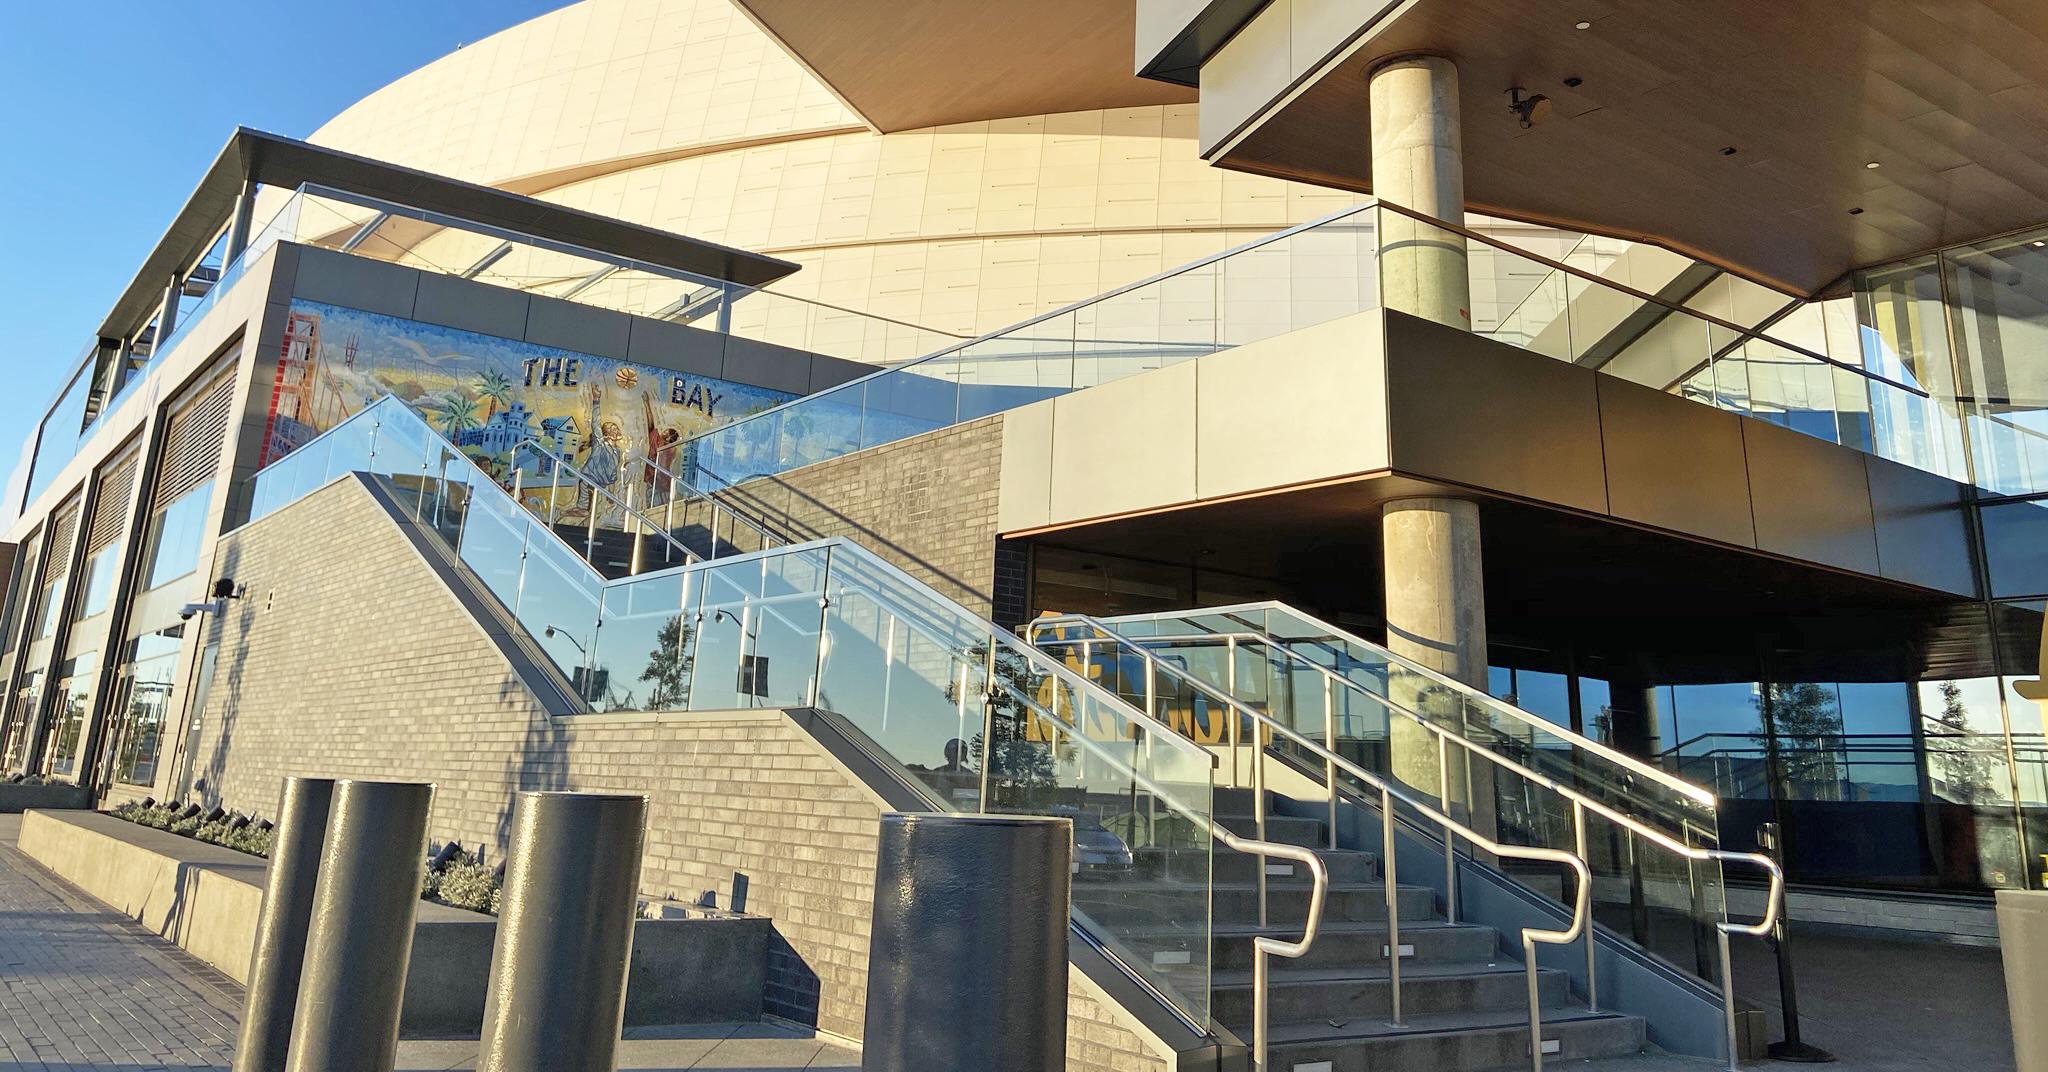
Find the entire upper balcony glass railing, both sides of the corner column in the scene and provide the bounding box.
[680,203,1962,496]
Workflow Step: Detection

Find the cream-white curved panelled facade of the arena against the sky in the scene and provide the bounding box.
[313,0,1561,348]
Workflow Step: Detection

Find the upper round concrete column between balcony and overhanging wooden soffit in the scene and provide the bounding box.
[1368,55,1473,328]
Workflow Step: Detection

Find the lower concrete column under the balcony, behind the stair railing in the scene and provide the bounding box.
[1380,498,1493,836]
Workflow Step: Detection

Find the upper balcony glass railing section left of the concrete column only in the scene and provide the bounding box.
[678,205,1378,488]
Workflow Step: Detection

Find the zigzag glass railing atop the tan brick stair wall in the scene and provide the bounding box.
[250,398,1228,1029]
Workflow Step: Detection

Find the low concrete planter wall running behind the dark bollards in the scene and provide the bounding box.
[20,810,770,1037]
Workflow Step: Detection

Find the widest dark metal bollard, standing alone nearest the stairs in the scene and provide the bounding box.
[860,814,1073,1072]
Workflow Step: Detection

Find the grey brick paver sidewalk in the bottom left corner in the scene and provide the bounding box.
[0,828,242,1072]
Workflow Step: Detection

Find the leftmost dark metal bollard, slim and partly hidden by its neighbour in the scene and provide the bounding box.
[233,777,334,1072]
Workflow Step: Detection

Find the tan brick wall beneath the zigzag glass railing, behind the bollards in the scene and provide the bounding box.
[193,480,1165,1072]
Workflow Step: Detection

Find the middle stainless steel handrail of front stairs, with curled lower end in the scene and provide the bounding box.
[1030,615,1593,1072]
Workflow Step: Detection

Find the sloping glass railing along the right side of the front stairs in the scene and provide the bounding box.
[1073,603,1726,982]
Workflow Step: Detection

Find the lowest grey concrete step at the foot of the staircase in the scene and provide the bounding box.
[1270,1004,1645,1072]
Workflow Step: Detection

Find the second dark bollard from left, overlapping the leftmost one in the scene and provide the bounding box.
[285,781,434,1072]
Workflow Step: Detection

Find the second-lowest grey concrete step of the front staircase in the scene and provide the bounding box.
[1210,959,1571,1031]
